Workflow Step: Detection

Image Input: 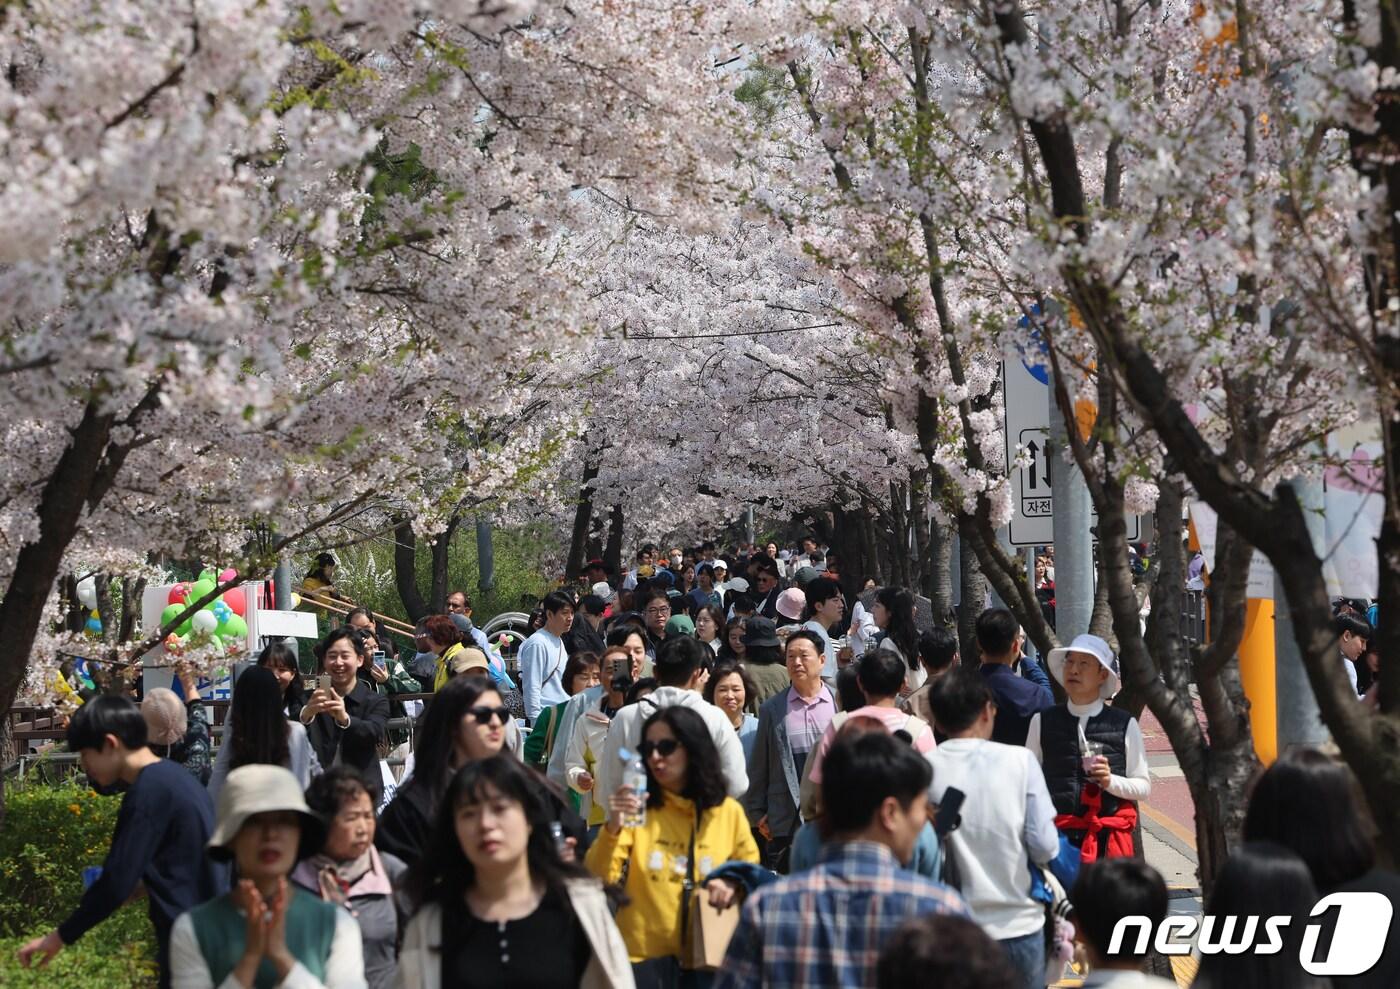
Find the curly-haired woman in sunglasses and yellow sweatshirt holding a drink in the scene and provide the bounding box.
[587,706,759,989]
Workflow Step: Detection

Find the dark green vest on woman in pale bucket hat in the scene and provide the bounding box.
[189,883,339,989]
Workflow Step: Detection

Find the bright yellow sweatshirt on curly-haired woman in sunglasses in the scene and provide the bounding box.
[584,793,759,962]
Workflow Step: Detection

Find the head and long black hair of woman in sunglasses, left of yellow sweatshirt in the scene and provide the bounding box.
[374,677,511,866]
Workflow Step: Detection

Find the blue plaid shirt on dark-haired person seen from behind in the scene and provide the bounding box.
[714,842,969,989]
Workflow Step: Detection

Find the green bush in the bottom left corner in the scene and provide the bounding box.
[0,782,155,989]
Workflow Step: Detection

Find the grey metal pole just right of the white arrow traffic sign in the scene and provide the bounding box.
[1046,373,1093,642]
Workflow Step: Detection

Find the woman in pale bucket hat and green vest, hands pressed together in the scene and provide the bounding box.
[171,765,365,989]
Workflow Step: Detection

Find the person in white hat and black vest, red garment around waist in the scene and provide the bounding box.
[1026,635,1152,862]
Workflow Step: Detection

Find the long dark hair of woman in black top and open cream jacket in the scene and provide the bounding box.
[407,756,588,909]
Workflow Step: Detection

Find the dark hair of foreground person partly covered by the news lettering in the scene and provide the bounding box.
[1191,842,1331,989]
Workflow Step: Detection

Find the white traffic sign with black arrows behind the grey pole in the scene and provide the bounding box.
[1001,348,1142,546]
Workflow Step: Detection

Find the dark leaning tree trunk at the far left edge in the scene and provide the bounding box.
[0,399,115,716]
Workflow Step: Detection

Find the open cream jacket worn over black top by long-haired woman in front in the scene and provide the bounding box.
[393,880,636,989]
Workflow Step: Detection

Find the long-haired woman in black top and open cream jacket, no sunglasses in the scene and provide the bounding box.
[395,755,633,989]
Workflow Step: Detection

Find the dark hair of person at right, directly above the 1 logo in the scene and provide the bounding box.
[1245,748,1375,892]
